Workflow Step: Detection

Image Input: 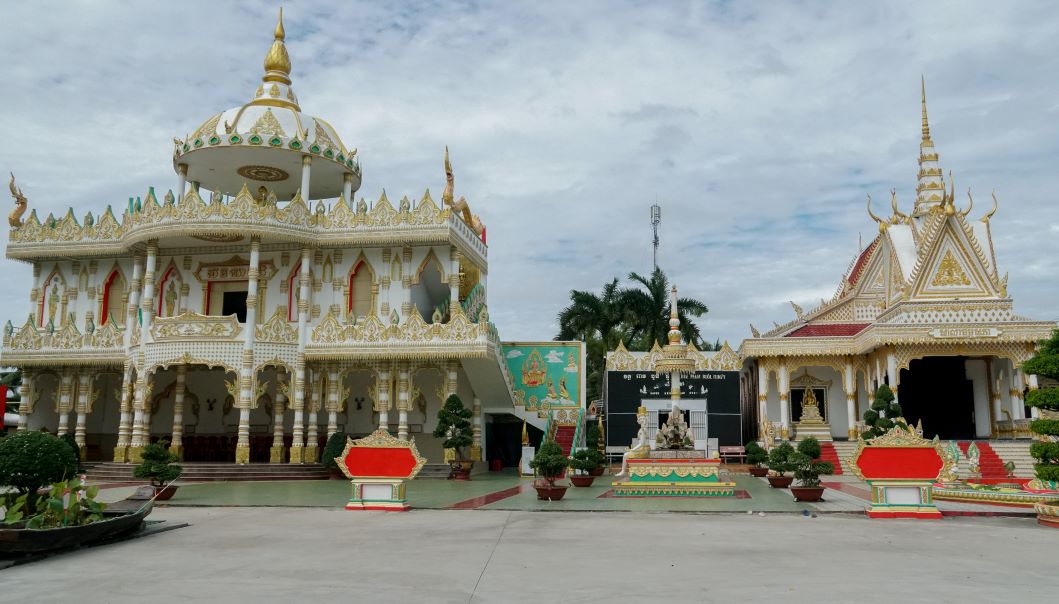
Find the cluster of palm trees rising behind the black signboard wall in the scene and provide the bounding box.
[555,269,720,401]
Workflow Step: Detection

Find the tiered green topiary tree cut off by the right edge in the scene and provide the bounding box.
[1022,330,1059,482]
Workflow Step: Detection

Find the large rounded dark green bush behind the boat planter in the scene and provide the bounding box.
[0,431,77,500]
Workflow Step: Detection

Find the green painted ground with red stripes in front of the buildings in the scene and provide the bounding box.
[160,473,834,512]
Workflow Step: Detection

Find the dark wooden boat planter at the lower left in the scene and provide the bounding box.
[0,502,151,557]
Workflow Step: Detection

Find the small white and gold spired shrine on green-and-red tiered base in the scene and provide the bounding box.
[612,287,735,497]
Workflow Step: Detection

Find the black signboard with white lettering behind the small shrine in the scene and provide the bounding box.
[604,371,742,447]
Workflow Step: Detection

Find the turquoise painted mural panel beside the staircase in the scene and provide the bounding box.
[502,342,585,411]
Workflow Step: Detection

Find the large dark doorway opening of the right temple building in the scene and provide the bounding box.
[897,356,974,440]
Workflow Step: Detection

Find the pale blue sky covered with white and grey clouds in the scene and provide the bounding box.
[0,0,1059,345]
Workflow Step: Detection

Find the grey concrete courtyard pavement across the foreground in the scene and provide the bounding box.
[0,507,1059,603]
